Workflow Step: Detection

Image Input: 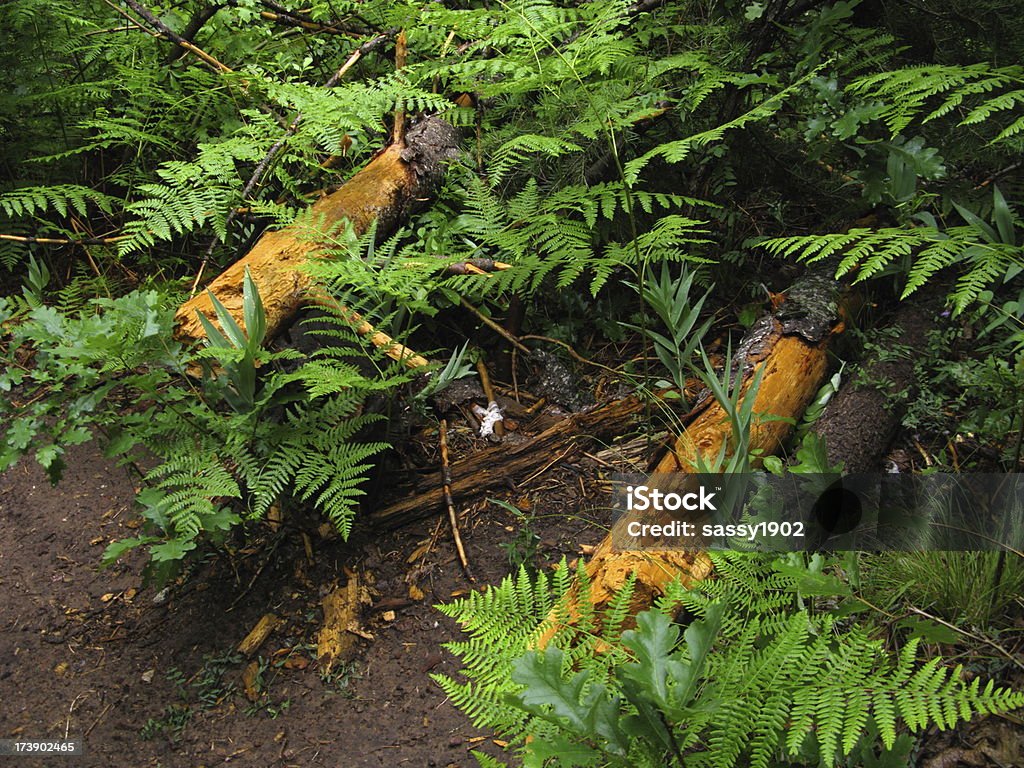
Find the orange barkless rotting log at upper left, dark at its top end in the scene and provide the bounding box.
[174,117,459,356]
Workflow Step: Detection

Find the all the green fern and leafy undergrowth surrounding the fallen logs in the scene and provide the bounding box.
[0,0,1024,766]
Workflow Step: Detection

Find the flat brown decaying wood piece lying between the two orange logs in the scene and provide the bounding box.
[369,397,644,527]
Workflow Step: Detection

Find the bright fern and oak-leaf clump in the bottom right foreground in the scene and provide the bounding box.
[437,554,1024,768]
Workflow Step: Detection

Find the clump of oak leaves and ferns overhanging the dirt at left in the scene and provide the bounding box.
[0,268,411,581]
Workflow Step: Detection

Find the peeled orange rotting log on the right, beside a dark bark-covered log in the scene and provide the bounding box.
[537,266,844,647]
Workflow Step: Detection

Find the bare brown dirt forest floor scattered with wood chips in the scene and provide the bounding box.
[0,428,607,768]
